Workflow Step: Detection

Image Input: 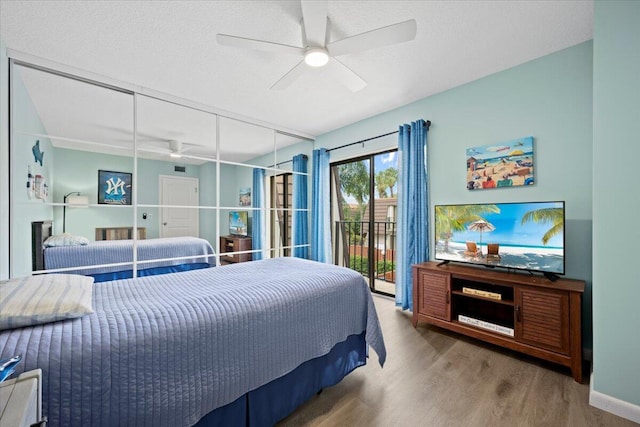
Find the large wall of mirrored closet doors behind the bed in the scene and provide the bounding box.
[10,61,313,279]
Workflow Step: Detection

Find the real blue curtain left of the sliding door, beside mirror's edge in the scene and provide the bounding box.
[311,148,331,263]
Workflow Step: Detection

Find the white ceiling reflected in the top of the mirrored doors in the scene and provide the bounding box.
[13,62,300,164]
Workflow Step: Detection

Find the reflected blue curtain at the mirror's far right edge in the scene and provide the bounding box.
[291,154,309,258]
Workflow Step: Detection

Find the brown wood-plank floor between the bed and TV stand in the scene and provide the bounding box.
[278,295,638,427]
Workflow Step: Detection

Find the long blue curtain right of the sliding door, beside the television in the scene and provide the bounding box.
[396,120,429,311]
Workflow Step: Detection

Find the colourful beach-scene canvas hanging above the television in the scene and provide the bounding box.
[467,136,534,190]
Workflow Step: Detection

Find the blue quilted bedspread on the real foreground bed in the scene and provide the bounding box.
[0,258,386,427]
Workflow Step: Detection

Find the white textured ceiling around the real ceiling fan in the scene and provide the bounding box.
[0,0,593,145]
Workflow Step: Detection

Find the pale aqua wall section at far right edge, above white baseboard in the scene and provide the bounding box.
[593,1,640,414]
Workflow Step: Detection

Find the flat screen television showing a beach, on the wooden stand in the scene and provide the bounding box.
[435,202,565,280]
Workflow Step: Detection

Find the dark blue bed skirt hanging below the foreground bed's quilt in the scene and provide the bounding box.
[196,332,367,427]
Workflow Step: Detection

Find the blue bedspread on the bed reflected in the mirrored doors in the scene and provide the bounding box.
[44,237,215,275]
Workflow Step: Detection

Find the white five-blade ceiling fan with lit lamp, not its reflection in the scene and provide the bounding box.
[216,0,417,92]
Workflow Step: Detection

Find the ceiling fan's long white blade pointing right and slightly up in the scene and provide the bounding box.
[327,19,418,56]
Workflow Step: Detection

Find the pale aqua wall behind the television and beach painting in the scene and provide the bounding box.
[315,42,593,348]
